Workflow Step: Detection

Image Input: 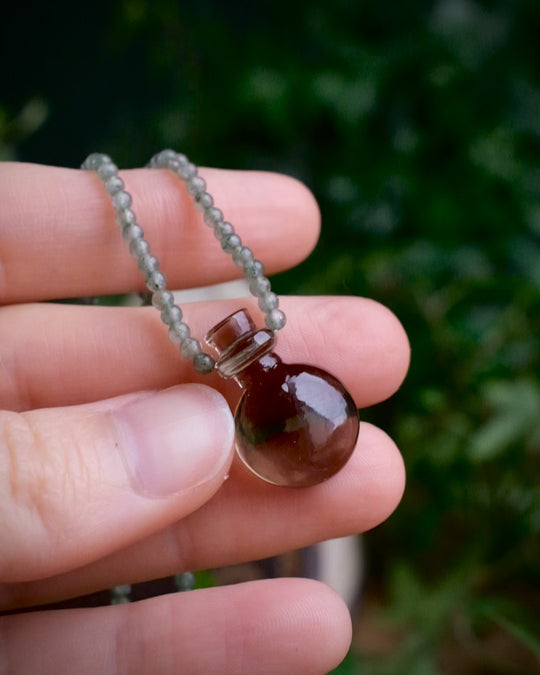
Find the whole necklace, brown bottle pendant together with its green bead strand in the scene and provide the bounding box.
[82,150,359,487]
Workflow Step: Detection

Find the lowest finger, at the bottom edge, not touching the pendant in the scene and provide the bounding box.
[0,579,351,675]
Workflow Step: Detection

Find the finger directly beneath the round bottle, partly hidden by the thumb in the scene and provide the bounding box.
[0,423,405,609]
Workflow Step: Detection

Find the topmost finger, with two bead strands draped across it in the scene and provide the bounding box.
[0,162,319,304]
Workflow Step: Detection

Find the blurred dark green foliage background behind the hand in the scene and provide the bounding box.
[0,0,540,675]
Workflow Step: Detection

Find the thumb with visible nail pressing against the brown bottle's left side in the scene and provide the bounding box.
[0,384,234,582]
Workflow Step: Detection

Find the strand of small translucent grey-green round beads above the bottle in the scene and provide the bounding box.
[81,150,286,375]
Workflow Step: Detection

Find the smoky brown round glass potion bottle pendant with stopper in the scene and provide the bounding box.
[206,309,359,487]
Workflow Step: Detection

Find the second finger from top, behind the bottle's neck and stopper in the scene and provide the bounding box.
[0,297,409,410]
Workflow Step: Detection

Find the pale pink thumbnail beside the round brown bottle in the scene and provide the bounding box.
[112,384,234,497]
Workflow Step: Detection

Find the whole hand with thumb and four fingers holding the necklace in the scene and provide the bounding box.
[0,163,409,675]
